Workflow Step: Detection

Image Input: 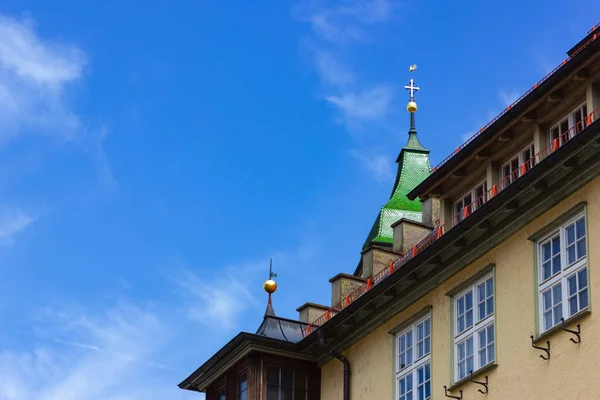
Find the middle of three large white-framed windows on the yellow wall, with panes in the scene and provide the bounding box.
[454,274,495,381]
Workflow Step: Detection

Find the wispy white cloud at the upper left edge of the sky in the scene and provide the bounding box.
[0,14,115,185]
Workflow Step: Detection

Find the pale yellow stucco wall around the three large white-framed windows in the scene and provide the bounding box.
[321,178,600,400]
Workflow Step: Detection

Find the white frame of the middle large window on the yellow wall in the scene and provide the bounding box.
[452,271,497,382]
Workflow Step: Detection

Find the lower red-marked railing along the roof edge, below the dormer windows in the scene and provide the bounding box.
[303,107,600,336]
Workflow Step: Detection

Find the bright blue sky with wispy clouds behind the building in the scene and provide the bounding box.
[0,0,600,400]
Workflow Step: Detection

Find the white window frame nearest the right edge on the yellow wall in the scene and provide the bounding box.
[534,209,591,335]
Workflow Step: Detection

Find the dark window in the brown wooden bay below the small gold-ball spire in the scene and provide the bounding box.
[267,367,308,400]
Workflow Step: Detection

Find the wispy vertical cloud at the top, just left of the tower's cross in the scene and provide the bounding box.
[295,0,400,182]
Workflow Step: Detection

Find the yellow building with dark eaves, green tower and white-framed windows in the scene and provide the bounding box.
[180,26,600,400]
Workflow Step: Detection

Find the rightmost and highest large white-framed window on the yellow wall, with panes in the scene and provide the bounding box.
[537,214,589,332]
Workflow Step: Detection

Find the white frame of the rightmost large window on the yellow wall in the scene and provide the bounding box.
[536,212,590,333]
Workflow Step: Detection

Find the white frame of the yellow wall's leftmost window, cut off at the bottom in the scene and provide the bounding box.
[394,312,432,400]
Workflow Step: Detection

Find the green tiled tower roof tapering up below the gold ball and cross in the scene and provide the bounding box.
[363,112,430,249]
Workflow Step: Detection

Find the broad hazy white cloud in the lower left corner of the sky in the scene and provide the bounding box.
[0,305,185,400]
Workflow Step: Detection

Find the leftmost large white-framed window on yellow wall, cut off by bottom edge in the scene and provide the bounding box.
[396,315,431,400]
